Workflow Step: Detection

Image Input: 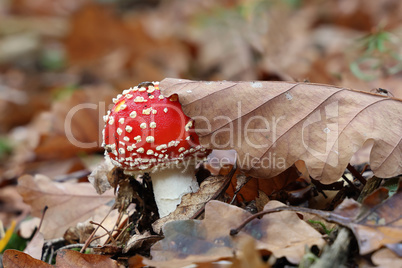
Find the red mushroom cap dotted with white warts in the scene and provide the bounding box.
[103,82,207,171]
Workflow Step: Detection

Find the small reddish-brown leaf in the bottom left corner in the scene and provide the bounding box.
[3,249,53,268]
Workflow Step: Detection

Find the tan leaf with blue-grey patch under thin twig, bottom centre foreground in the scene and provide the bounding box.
[144,201,324,267]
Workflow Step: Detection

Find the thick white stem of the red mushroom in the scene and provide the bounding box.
[150,164,199,218]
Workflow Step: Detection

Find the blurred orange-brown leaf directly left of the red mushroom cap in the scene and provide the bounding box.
[35,86,115,160]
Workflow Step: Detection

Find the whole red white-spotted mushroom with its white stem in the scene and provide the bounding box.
[103,82,207,217]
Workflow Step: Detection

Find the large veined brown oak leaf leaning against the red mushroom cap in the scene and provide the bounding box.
[160,78,402,183]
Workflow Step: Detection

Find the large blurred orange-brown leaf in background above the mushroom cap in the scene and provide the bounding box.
[65,3,189,81]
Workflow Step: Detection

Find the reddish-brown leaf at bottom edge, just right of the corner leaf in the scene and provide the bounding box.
[56,249,118,268]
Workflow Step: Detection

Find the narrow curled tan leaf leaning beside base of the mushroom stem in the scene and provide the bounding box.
[152,176,227,233]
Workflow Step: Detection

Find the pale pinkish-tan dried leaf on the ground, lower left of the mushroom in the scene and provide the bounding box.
[17,175,114,239]
